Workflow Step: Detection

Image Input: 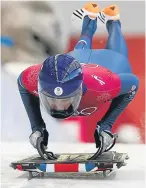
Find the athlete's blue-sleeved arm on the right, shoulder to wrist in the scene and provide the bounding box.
[97,73,139,131]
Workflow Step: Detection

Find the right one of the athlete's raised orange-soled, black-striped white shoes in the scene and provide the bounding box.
[98,5,120,24]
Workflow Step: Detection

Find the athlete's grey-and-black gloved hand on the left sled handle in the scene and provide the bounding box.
[29,128,49,148]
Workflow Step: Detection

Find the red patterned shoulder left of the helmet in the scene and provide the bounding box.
[21,64,42,94]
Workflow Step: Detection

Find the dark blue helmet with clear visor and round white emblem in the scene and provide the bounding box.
[38,54,83,119]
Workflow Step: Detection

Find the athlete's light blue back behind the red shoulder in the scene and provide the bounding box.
[68,49,132,74]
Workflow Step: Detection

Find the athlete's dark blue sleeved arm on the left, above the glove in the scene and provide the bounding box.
[17,72,45,132]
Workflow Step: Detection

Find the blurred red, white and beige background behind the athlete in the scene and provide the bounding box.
[1,1,145,143]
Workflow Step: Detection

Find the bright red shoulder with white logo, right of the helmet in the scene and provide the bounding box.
[82,64,121,96]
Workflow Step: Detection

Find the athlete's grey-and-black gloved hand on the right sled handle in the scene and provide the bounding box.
[94,127,114,154]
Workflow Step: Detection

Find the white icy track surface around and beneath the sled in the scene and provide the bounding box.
[1,142,145,188]
